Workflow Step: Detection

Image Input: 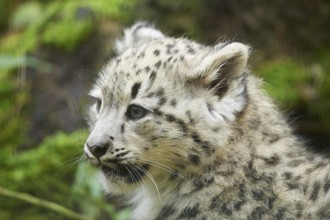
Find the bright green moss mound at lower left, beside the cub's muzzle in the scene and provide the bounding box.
[0,130,87,219]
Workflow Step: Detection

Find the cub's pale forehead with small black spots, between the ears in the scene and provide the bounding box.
[97,38,207,98]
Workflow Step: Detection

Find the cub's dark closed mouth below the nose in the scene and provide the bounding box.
[101,164,149,183]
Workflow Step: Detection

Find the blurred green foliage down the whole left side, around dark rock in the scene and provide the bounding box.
[0,0,133,220]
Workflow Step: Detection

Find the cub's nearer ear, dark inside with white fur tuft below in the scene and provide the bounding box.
[190,43,249,120]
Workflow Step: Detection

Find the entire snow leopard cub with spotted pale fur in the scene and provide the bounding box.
[84,22,330,220]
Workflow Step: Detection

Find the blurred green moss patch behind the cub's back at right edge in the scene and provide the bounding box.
[257,55,330,131]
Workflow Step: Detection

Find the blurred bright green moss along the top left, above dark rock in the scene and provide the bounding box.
[0,0,135,56]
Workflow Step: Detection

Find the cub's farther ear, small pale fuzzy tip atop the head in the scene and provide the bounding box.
[114,22,164,54]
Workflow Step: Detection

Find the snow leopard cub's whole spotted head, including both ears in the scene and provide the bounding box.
[84,23,248,193]
